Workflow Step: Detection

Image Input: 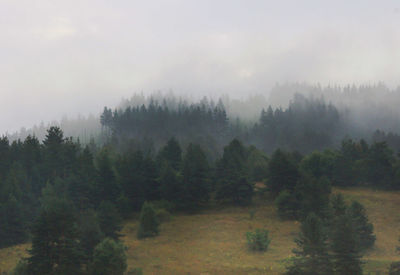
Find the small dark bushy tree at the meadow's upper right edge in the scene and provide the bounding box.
[275,190,300,219]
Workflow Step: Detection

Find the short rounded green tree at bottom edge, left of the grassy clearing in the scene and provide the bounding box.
[91,238,128,275]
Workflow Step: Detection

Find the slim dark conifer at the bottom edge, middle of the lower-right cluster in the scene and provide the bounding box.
[331,215,362,275]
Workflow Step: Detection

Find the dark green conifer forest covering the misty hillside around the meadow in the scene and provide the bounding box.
[0,88,400,274]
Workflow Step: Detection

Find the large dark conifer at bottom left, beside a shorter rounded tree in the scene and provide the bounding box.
[28,198,83,274]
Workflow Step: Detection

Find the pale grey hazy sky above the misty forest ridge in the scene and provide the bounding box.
[0,0,400,133]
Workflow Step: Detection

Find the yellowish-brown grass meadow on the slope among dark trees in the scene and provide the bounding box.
[0,188,400,275]
